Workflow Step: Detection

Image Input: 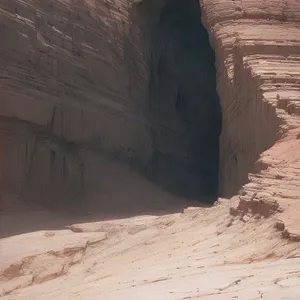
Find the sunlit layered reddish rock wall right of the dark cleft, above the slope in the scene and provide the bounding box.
[200,0,300,196]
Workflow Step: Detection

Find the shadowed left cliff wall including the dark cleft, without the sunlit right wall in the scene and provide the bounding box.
[0,0,221,202]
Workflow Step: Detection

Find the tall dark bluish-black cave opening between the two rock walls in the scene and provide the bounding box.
[138,0,222,203]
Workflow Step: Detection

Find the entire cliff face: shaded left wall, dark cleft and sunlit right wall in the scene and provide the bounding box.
[0,0,300,209]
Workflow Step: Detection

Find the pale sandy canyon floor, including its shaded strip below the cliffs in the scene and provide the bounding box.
[0,145,300,300]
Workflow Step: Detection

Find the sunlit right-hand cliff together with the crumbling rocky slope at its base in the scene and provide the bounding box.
[201,0,300,241]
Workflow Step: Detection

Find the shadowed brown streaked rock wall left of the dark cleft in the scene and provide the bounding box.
[0,0,151,204]
